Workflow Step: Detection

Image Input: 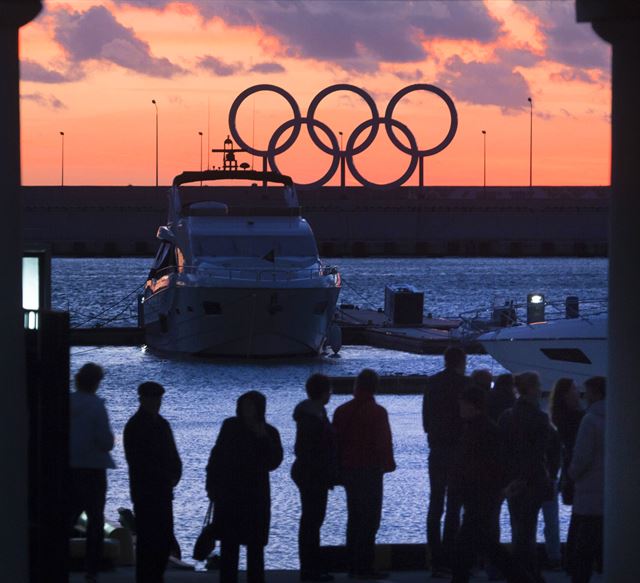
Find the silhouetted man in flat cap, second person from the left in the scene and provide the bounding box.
[124,382,182,583]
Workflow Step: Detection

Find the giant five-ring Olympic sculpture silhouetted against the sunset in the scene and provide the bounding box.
[229,83,458,189]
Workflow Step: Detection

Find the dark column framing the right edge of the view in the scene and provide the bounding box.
[577,0,640,583]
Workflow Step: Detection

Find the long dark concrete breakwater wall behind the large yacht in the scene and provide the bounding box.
[23,186,610,257]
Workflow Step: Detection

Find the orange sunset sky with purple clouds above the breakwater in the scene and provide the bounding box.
[20,0,611,185]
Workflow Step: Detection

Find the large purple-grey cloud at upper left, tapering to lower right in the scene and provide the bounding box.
[54,6,184,78]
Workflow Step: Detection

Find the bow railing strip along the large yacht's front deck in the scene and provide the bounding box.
[149,265,340,285]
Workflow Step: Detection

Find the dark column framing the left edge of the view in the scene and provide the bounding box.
[0,0,41,581]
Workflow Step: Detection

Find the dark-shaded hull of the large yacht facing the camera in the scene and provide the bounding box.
[143,287,339,357]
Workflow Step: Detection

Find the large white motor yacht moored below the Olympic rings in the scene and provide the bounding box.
[140,170,340,357]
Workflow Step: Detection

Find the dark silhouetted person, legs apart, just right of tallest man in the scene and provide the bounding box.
[452,385,532,583]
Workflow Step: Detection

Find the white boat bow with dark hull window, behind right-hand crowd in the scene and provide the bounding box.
[460,300,608,389]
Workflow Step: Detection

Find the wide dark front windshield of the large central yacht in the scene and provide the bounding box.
[193,236,318,261]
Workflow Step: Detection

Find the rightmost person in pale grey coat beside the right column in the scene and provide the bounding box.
[569,377,606,583]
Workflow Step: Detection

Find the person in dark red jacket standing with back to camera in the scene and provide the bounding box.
[333,369,396,579]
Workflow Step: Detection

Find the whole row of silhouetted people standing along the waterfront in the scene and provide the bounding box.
[70,348,606,583]
